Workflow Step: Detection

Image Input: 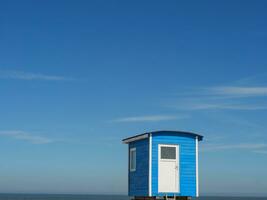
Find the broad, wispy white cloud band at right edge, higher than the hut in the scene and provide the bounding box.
[168,86,267,111]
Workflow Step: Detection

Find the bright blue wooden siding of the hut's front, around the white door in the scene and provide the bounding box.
[152,132,196,197]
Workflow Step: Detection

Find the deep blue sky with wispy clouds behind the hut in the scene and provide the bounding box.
[0,1,267,195]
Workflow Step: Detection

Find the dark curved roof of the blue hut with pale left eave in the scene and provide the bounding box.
[122,130,203,144]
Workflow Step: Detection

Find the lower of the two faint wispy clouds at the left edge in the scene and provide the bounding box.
[0,130,54,144]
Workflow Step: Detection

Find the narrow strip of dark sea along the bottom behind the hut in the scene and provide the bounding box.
[0,194,267,200]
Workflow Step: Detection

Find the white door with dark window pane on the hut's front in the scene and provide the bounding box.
[158,144,180,193]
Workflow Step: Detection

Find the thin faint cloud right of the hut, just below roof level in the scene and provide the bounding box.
[202,143,267,152]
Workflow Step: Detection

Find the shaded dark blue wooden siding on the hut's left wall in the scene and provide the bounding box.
[128,139,149,196]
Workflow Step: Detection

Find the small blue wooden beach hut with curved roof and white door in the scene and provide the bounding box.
[122,131,203,199]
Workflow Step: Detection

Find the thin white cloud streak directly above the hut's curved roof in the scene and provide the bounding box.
[112,115,189,122]
